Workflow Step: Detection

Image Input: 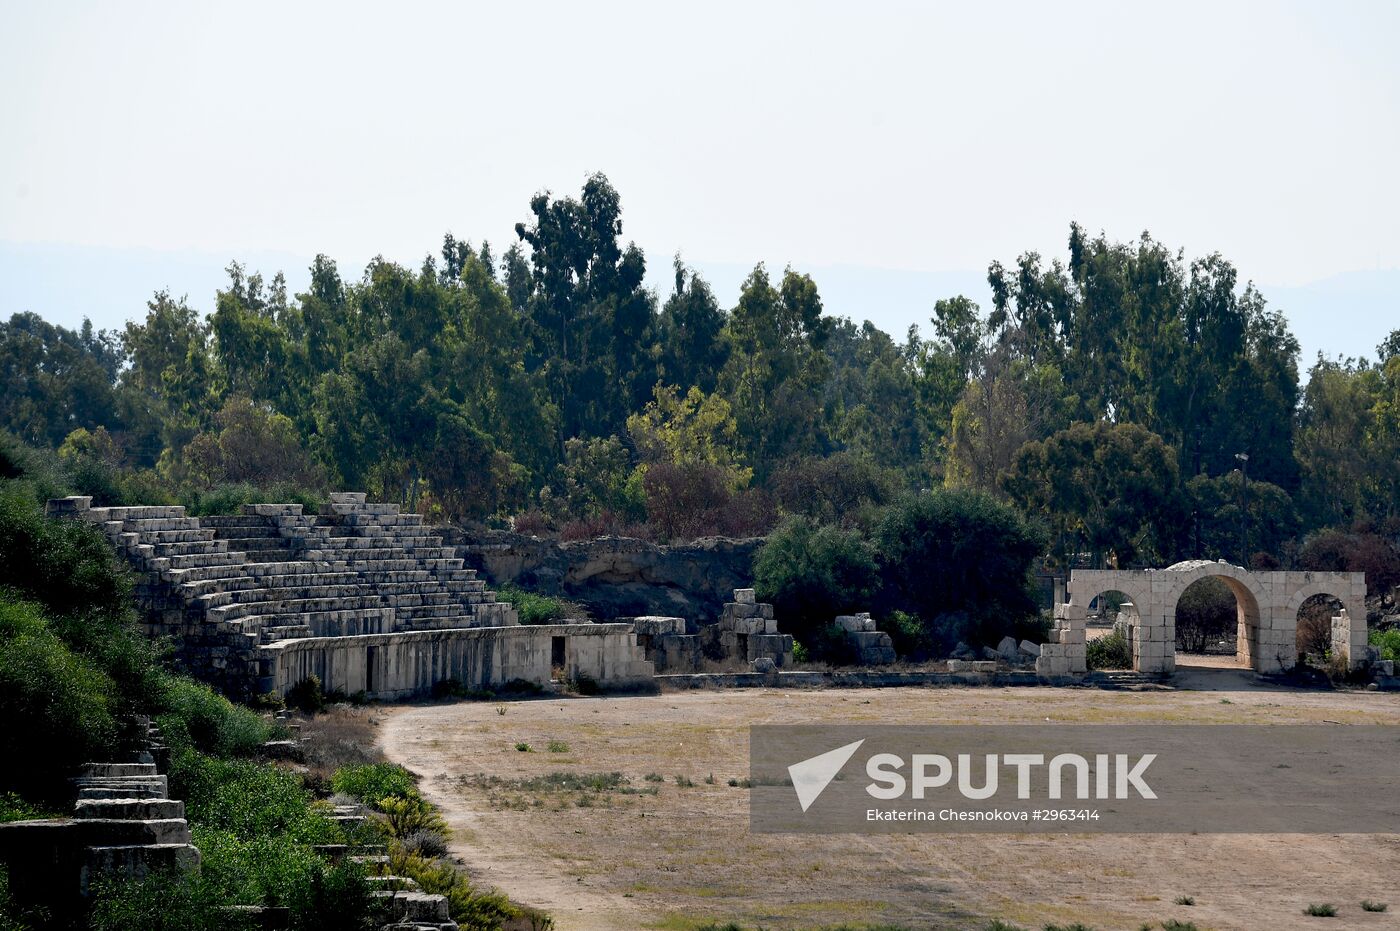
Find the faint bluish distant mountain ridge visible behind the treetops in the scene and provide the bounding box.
[0,242,1400,371]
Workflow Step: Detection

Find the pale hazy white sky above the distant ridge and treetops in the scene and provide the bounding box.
[0,0,1400,344]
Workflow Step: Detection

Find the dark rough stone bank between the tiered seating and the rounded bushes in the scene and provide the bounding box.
[437,528,763,624]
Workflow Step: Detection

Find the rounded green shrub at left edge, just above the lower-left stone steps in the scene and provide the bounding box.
[0,595,119,798]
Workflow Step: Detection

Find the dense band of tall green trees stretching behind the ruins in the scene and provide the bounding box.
[0,175,1400,566]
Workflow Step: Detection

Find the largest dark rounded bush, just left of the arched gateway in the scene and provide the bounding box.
[868,490,1046,651]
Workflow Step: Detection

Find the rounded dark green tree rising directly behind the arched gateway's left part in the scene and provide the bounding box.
[1002,421,1182,567]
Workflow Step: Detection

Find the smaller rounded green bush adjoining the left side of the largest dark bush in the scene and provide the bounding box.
[753,518,879,662]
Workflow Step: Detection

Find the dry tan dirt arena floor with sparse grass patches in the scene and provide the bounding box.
[379,674,1400,931]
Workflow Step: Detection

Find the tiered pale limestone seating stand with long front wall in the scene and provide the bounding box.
[49,493,652,699]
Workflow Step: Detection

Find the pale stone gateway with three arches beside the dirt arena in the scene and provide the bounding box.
[1047,560,1366,672]
